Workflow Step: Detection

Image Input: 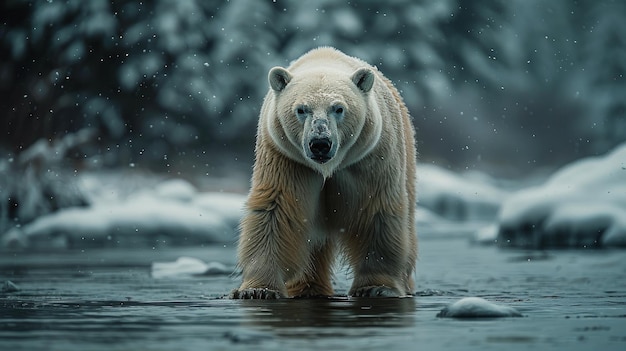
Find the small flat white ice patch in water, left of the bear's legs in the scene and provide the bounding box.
[152,257,232,279]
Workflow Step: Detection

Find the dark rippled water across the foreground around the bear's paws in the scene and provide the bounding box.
[0,238,626,350]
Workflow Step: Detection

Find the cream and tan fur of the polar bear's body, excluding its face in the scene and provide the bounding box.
[231,48,417,298]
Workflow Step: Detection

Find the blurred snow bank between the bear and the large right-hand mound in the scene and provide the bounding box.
[417,164,508,221]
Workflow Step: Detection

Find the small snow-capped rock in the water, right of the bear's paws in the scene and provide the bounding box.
[437,297,522,318]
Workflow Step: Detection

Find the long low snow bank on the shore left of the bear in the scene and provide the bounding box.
[0,180,245,252]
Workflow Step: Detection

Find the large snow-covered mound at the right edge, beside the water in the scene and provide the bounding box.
[494,144,626,248]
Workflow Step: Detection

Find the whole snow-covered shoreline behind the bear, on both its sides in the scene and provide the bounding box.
[0,144,626,250]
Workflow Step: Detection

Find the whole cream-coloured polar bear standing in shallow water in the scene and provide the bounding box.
[230,47,417,299]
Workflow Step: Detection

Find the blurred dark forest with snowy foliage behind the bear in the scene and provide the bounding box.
[0,0,626,181]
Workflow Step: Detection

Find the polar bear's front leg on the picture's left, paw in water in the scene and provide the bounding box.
[230,156,321,299]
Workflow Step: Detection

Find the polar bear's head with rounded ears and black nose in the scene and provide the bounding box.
[268,67,376,177]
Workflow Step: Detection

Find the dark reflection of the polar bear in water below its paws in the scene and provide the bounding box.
[235,297,417,337]
